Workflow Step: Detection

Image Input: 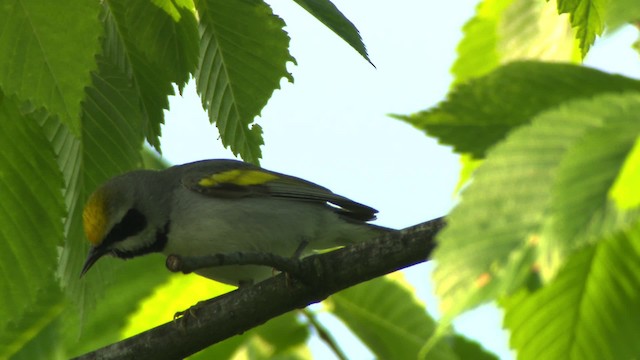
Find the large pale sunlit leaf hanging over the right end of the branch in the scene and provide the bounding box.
[434,93,640,316]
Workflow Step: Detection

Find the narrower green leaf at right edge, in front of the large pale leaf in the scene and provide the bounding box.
[538,119,640,279]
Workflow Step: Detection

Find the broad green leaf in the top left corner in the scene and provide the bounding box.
[0,0,102,135]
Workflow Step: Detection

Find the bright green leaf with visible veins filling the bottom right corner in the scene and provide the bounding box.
[502,223,640,360]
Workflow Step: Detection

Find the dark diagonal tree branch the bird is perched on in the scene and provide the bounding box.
[76,218,444,359]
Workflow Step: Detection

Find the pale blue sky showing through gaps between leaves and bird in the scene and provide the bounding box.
[162,0,640,359]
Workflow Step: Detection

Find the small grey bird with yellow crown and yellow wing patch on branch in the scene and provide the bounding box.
[82,160,392,285]
